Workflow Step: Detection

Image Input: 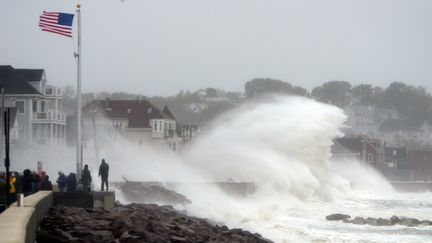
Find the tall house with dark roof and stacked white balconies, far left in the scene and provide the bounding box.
[0,66,66,145]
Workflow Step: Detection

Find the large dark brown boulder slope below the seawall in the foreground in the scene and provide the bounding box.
[37,204,271,243]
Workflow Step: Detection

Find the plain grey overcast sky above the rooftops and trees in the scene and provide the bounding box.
[0,0,432,96]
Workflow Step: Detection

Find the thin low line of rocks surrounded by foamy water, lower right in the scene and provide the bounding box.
[326,213,432,227]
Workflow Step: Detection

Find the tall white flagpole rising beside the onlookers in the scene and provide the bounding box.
[76,3,83,179]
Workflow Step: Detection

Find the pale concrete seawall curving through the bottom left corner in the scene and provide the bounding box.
[0,191,53,243]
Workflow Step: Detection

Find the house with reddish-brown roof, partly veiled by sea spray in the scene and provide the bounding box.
[83,99,183,151]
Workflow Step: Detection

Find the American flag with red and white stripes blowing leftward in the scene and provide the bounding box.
[39,11,74,37]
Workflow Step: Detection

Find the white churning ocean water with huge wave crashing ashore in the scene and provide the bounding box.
[115,97,432,242]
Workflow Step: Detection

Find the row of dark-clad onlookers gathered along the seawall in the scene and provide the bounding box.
[0,159,109,207]
